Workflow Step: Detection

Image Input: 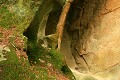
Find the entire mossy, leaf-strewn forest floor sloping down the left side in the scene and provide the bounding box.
[0,0,73,80]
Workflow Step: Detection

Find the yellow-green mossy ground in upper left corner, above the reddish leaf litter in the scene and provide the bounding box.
[0,0,38,28]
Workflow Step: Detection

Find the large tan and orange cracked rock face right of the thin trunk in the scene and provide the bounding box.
[61,0,120,80]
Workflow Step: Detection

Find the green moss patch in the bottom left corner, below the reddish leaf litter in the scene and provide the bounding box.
[0,48,54,80]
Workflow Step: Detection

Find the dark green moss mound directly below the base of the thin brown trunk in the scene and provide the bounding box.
[27,46,64,70]
